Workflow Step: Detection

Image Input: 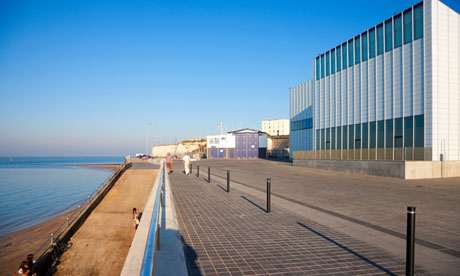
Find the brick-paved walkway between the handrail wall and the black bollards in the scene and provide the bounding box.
[170,167,434,276]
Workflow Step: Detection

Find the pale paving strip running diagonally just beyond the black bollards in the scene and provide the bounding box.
[208,172,460,275]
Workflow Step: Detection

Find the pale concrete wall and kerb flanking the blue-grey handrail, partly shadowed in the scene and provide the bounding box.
[120,161,188,276]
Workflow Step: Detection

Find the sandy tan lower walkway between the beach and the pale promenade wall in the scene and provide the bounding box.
[54,160,158,276]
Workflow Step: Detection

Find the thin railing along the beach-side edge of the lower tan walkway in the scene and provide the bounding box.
[33,165,124,260]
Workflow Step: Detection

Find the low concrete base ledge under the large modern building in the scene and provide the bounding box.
[293,159,460,179]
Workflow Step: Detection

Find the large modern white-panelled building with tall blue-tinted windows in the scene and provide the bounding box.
[290,0,460,178]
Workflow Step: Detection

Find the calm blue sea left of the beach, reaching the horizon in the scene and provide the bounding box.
[0,157,123,235]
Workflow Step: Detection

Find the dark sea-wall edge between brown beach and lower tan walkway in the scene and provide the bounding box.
[34,163,132,275]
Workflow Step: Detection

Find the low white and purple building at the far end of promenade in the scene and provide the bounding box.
[206,128,267,159]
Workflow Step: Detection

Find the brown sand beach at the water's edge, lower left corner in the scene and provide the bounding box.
[0,211,72,276]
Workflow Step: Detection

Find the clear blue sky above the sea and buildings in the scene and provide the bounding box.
[0,0,460,156]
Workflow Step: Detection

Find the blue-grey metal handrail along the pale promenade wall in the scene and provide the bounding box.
[140,161,166,276]
